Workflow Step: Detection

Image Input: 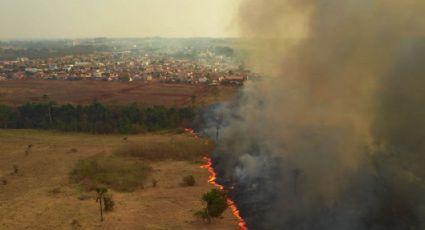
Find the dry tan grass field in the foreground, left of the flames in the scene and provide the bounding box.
[0,130,238,230]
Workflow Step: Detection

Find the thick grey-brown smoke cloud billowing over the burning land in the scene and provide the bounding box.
[202,0,425,230]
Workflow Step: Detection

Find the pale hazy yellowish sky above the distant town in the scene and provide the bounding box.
[0,0,240,39]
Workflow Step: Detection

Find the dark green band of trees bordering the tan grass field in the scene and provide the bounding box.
[0,102,195,133]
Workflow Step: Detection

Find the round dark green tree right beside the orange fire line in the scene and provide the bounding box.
[195,189,228,223]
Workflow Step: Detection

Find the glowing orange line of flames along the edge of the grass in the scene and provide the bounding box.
[184,128,248,230]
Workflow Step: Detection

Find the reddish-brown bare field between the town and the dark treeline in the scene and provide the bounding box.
[0,80,236,106]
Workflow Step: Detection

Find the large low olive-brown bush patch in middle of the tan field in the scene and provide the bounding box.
[70,155,151,192]
